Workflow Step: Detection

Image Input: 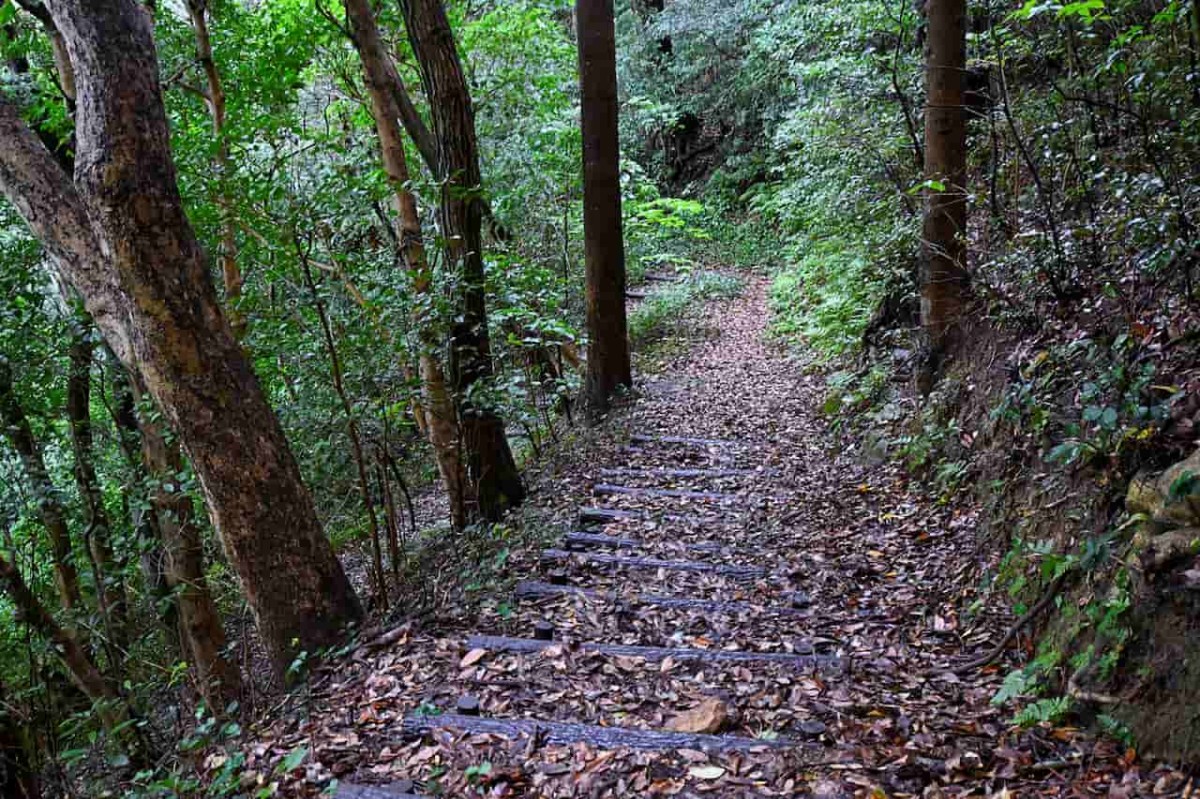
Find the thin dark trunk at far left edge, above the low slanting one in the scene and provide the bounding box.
[0,358,82,611]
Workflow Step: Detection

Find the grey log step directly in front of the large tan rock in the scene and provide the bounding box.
[401,714,797,752]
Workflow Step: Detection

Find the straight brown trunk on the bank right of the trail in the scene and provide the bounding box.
[920,0,968,391]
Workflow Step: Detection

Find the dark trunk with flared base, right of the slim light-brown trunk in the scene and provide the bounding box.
[400,0,524,522]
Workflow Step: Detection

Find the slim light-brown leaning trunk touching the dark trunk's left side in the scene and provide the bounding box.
[346,0,466,529]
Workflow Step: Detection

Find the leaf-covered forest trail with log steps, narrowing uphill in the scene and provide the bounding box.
[276,280,1147,797]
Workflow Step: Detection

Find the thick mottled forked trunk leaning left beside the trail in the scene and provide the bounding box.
[0,0,361,673]
